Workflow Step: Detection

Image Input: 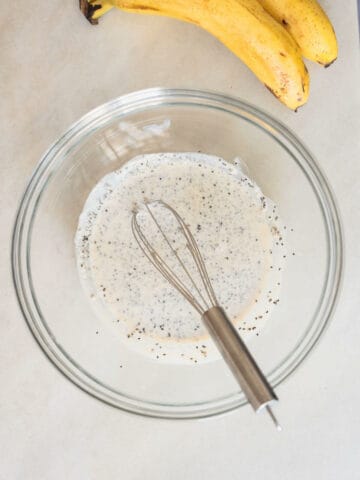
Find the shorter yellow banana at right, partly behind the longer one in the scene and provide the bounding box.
[258,0,338,67]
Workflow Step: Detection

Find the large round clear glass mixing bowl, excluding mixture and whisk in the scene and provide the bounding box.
[12,88,342,418]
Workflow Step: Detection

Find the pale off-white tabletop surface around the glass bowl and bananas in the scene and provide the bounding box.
[0,0,360,480]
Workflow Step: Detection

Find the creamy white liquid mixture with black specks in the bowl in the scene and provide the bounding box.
[75,153,286,363]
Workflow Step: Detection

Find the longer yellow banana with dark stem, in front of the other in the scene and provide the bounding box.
[80,0,309,110]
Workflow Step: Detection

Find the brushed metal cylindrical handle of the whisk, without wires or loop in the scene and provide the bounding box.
[202,307,277,411]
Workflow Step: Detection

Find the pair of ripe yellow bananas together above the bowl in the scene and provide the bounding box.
[80,0,337,110]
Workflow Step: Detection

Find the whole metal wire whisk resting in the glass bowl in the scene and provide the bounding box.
[132,200,281,430]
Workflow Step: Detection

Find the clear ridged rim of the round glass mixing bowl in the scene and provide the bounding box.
[11,87,343,419]
